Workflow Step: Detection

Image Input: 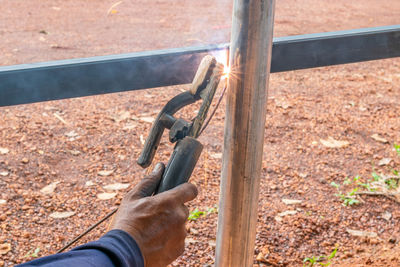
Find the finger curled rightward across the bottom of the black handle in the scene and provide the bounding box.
[156,183,198,203]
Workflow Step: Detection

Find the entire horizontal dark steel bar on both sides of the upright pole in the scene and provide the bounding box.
[0,25,400,106]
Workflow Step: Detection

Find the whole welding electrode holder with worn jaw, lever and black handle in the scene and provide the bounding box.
[137,56,223,193]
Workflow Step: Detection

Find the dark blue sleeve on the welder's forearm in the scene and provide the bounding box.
[18,230,144,267]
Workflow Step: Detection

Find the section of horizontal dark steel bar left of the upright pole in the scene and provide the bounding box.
[0,45,226,106]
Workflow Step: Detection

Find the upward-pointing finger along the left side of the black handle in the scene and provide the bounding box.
[132,162,165,198]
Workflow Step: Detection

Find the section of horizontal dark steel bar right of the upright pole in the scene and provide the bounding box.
[271,25,400,72]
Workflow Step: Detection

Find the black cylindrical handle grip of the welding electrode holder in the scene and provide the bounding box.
[156,136,203,194]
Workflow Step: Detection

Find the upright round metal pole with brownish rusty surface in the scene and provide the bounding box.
[215,0,275,267]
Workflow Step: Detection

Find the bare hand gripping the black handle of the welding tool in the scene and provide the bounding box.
[110,163,197,267]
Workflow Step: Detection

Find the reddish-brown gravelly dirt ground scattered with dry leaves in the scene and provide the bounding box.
[0,0,400,266]
